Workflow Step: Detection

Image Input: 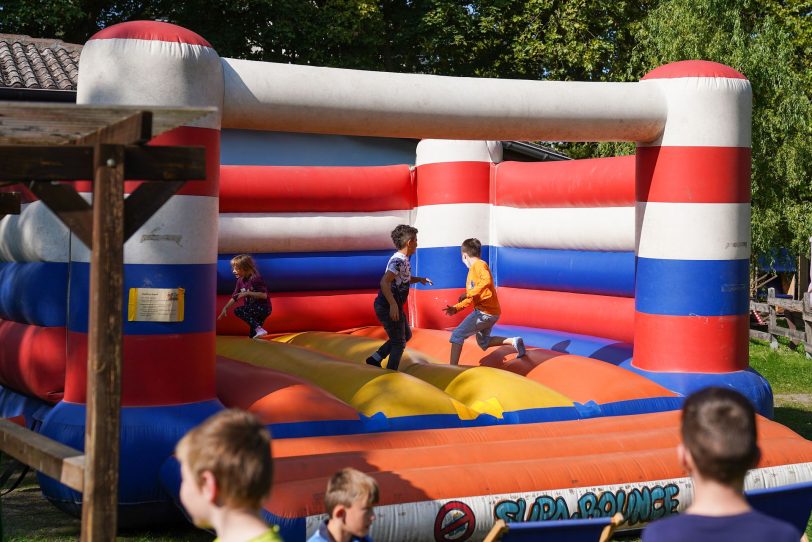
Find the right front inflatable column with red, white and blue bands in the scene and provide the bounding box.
[633,61,752,373]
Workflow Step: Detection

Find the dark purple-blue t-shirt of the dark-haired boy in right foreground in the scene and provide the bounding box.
[642,510,801,542]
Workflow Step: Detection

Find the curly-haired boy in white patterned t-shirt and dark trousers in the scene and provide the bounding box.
[367,224,432,371]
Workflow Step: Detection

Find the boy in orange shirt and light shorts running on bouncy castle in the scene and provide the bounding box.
[443,238,525,365]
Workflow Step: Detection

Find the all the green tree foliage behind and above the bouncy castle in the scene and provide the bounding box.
[0,0,812,253]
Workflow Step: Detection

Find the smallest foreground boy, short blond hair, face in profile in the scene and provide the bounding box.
[307,468,378,542]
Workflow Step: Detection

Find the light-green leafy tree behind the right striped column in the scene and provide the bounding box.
[629,0,812,260]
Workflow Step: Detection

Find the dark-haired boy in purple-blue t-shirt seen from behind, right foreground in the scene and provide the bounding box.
[643,388,801,542]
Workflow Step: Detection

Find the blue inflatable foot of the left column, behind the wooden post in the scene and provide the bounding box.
[37,400,223,529]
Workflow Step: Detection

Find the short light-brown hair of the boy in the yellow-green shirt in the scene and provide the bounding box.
[175,409,273,510]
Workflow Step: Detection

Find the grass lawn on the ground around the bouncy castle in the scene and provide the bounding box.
[0,341,812,542]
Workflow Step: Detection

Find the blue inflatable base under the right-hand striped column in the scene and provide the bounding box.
[620,360,773,419]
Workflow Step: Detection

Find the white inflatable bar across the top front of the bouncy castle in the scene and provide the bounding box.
[222,58,667,142]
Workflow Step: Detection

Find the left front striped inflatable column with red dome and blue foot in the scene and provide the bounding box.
[36,22,223,526]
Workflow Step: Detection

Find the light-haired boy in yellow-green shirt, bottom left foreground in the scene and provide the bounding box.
[175,409,282,542]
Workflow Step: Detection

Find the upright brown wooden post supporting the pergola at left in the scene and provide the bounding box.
[81,144,124,542]
